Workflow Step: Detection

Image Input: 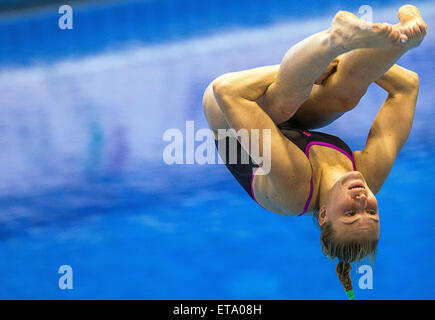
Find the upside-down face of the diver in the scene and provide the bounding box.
[319,171,380,239]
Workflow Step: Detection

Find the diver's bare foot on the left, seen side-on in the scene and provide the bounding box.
[329,11,406,51]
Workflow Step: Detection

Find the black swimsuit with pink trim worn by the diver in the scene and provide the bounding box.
[216,122,356,216]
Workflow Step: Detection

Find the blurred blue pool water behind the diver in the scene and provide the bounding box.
[0,0,435,299]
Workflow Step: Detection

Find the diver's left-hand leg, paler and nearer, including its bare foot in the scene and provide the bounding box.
[257,11,404,123]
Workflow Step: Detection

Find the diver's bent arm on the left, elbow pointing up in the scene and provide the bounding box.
[213,73,311,215]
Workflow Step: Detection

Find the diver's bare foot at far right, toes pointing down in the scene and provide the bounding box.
[395,4,427,49]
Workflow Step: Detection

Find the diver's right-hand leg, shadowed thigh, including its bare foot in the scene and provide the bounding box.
[293,5,427,128]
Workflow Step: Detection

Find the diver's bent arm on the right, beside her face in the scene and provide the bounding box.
[355,65,419,193]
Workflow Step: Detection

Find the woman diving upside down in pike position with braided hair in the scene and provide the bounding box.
[203,5,427,299]
